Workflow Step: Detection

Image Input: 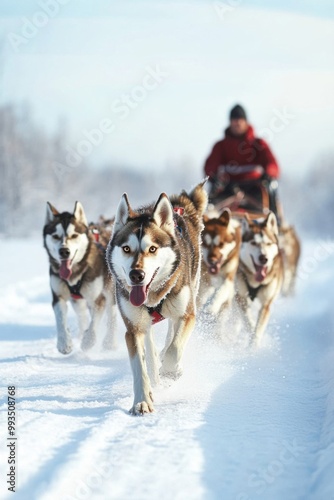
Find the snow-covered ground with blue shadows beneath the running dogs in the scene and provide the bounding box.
[0,235,334,500]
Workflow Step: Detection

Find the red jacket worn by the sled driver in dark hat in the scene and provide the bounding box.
[204,125,280,181]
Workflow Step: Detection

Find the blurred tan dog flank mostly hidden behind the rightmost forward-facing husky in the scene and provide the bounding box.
[279,226,300,296]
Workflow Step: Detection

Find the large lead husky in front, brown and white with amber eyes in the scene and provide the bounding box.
[107,182,207,415]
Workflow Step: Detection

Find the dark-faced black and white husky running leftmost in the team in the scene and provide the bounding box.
[43,201,116,354]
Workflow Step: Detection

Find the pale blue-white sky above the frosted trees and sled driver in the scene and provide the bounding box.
[0,0,334,178]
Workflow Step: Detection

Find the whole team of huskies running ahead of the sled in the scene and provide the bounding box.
[43,181,299,415]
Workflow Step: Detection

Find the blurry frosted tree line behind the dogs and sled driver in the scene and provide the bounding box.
[0,104,334,237]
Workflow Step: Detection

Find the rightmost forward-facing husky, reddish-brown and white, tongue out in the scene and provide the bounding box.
[236,212,283,345]
